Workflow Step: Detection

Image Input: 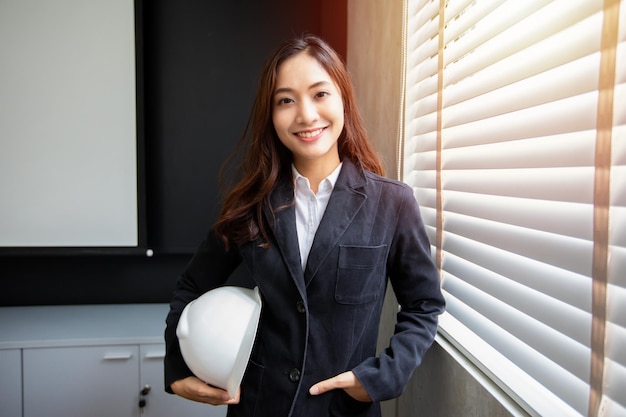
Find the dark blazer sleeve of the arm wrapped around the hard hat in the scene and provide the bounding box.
[164,232,241,393]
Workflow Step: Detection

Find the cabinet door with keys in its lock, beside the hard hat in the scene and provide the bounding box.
[140,344,226,417]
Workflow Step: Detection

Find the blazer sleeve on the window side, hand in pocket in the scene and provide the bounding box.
[353,186,445,401]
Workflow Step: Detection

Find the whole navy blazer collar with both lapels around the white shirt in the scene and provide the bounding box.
[264,159,367,295]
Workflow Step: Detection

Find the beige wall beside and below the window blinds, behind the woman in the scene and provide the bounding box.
[347,0,511,417]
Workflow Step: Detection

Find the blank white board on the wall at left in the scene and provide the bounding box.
[0,0,138,247]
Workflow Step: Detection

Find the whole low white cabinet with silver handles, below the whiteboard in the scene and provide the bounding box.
[0,305,226,417]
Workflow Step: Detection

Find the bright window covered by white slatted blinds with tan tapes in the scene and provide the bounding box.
[400,0,626,416]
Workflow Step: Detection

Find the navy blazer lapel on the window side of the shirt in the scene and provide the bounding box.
[304,160,367,286]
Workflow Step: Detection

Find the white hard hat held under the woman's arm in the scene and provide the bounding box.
[176,286,261,398]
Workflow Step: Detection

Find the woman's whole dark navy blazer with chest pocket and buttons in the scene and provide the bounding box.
[165,160,444,417]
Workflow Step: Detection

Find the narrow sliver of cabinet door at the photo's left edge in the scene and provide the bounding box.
[0,349,22,417]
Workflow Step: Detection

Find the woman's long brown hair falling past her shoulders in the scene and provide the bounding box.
[214,35,384,247]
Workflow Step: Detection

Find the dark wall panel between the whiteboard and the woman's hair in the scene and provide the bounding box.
[145,0,321,252]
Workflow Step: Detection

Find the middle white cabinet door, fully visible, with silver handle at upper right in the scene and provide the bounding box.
[23,345,139,417]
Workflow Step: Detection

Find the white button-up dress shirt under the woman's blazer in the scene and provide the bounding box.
[291,163,342,270]
